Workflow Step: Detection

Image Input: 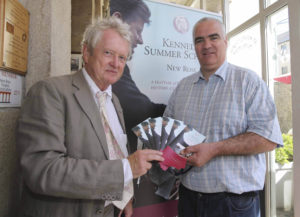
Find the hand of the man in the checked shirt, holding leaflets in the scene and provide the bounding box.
[180,143,216,167]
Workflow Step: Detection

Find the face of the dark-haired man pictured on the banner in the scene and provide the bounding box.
[128,19,145,53]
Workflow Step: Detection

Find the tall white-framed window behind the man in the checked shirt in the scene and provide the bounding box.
[225,0,294,217]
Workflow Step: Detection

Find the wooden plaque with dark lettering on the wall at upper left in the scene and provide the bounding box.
[0,0,29,75]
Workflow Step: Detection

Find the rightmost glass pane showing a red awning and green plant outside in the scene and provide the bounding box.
[267,7,293,217]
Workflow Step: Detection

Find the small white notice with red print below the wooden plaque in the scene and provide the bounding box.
[0,70,24,107]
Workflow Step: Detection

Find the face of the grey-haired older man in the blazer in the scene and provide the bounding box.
[83,29,129,90]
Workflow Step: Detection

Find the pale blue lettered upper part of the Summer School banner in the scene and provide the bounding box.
[130,0,222,104]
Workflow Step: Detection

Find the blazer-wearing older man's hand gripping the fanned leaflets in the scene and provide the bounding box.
[127,149,164,179]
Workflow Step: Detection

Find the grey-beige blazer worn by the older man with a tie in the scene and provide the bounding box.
[16,71,125,217]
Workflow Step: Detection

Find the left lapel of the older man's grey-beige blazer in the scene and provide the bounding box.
[72,71,109,159]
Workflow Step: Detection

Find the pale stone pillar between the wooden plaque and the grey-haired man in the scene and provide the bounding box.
[19,0,71,87]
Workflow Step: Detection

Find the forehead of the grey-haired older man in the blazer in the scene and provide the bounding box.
[95,29,130,55]
